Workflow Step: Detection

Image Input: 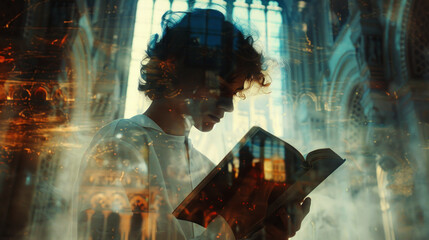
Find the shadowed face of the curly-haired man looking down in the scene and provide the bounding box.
[187,76,244,132]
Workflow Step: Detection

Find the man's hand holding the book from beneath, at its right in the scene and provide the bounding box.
[265,198,311,240]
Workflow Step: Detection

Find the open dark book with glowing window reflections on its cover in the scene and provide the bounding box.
[173,127,345,239]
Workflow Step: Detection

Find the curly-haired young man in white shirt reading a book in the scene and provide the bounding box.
[79,9,310,239]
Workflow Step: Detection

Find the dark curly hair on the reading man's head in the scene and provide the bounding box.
[138,9,269,100]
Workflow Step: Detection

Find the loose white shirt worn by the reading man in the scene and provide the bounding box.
[74,115,234,240]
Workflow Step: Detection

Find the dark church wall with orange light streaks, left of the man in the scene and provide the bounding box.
[0,0,136,239]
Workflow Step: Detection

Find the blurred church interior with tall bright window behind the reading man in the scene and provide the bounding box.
[0,0,429,240]
